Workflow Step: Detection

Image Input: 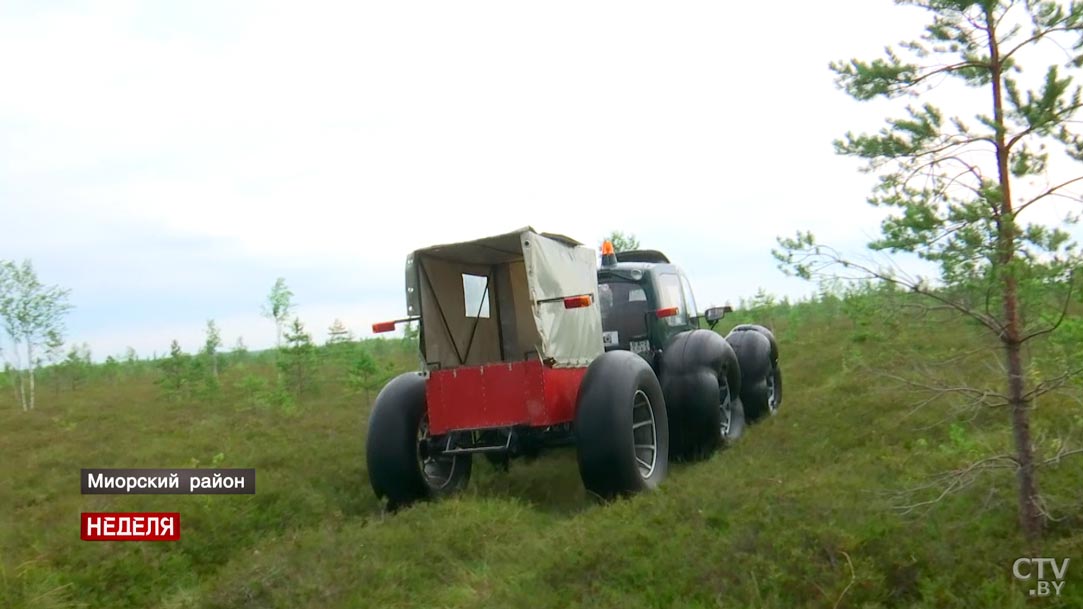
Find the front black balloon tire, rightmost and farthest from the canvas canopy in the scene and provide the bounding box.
[726,324,782,423]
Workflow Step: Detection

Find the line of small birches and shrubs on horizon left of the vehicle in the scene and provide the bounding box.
[0,266,417,411]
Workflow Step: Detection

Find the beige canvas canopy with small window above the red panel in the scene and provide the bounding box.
[406,226,603,368]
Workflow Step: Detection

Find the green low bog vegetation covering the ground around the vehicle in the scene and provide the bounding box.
[0,287,1083,609]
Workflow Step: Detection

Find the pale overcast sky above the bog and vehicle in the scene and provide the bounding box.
[0,0,1061,359]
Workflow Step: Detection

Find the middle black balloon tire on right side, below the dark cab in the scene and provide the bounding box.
[660,329,745,461]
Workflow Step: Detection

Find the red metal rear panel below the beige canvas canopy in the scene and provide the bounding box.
[426,360,586,433]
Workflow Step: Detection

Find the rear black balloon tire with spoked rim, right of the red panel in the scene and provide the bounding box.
[575,351,669,500]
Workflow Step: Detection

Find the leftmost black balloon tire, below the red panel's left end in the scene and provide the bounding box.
[365,373,471,509]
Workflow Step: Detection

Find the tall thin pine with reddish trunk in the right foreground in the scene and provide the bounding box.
[777,0,1083,540]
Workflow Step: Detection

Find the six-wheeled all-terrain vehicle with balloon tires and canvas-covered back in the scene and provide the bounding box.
[366,228,782,507]
